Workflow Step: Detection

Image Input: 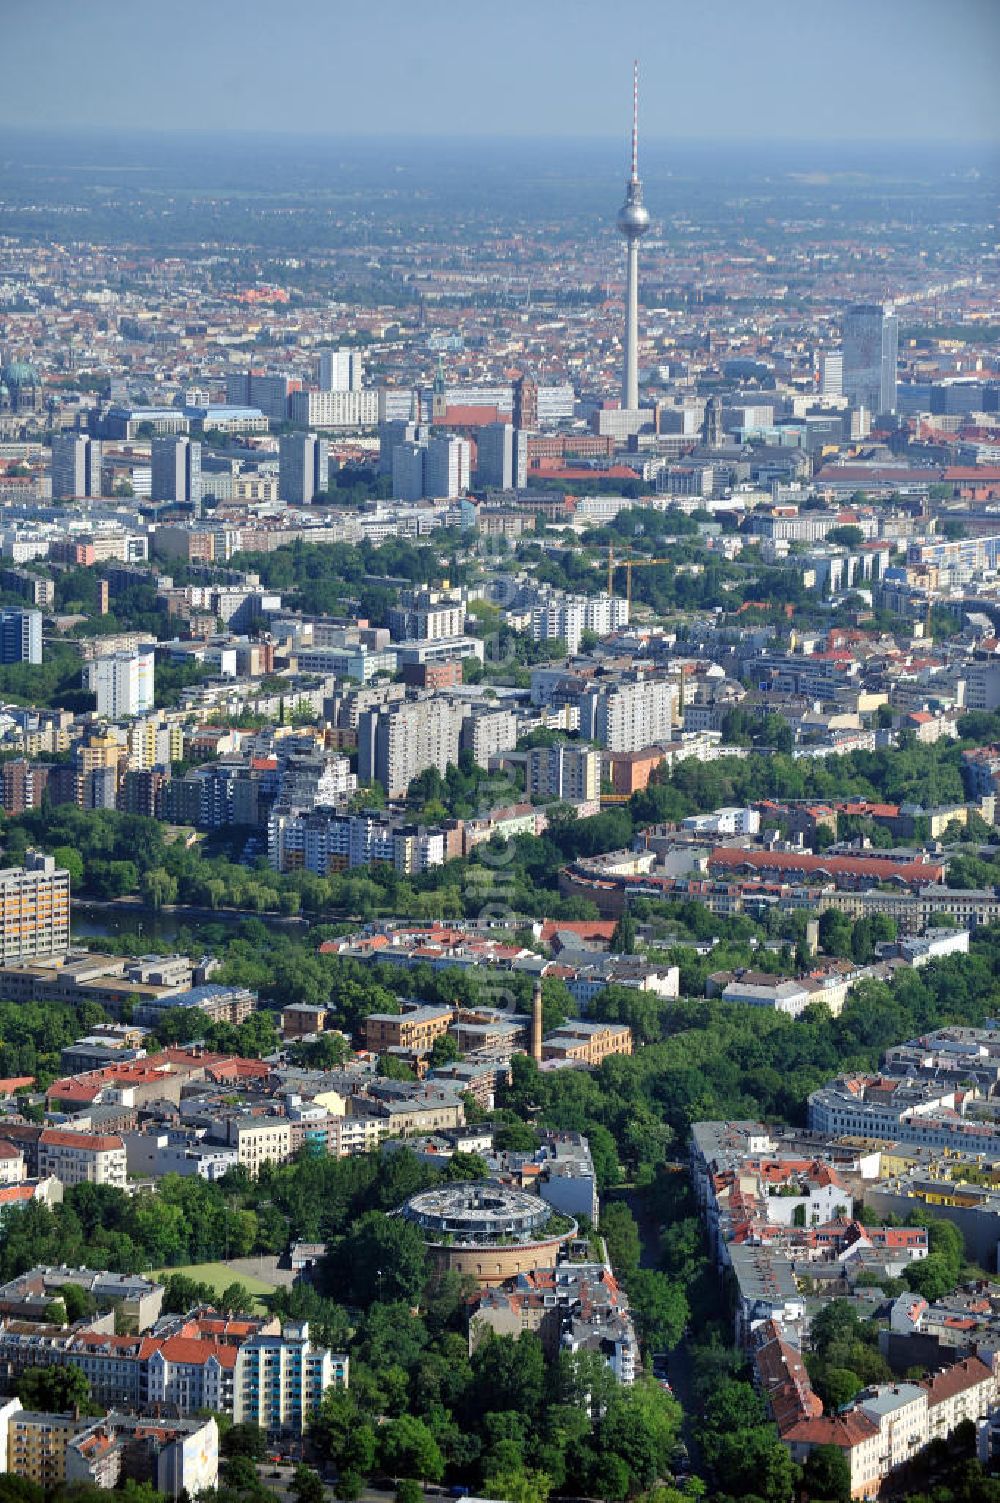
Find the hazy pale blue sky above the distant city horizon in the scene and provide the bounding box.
[0,0,1000,141]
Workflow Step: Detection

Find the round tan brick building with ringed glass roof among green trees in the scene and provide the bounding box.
[400,1180,577,1287]
